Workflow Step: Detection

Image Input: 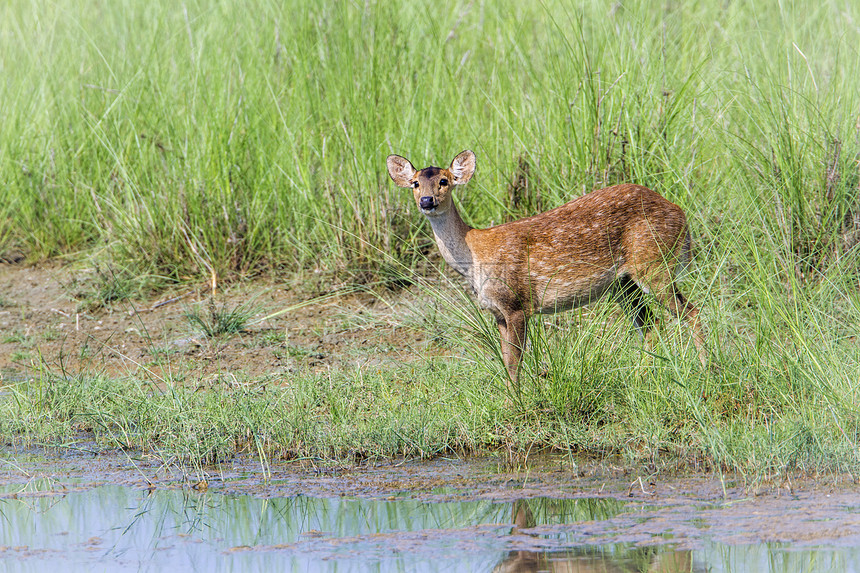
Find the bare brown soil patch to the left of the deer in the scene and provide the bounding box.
[0,263,443,383]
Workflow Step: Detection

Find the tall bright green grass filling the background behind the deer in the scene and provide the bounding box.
[0,0,860,279]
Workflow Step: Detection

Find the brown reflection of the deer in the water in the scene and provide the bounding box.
[493,499,694,573]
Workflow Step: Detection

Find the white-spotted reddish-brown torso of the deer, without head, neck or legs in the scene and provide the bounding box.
[466,184,687,312]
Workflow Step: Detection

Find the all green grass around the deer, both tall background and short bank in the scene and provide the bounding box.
[0,0,860,476]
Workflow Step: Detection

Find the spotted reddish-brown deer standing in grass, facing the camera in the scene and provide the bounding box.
[386,150,707,388]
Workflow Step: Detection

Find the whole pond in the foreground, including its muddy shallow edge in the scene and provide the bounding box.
[0,457,860,573]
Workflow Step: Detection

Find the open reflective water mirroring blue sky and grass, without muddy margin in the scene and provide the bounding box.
[0,479,860,573]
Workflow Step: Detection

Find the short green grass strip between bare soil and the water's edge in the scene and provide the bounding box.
[0,317,857,479]
